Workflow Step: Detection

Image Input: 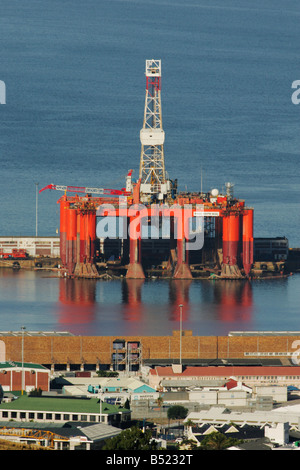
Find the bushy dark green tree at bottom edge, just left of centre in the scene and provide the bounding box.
[103,427,157,450]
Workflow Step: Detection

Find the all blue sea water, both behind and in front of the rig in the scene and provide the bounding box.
[0,0,300,334]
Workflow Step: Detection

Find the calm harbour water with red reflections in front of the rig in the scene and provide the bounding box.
[0,269,300,335]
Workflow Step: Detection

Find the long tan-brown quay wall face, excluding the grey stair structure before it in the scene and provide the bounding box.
[0,331,300,367]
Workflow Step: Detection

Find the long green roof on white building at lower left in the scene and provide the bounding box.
[0,395,128,414]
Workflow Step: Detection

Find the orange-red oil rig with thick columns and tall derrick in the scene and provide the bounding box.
[40,59,254,279]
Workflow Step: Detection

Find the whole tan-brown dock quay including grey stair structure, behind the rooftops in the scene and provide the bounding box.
[0,330,300,372]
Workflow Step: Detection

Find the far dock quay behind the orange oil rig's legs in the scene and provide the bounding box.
[0,236,300,279]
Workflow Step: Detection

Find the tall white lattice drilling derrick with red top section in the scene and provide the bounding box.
[139,59,170,202]
